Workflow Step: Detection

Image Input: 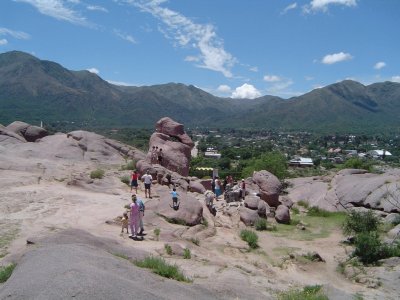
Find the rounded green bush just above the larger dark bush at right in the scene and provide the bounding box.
[343,210,380,234]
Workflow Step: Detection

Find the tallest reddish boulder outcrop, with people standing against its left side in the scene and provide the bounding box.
[146,118,194,176]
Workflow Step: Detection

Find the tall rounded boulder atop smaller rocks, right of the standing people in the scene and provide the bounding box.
[252,170,282,207]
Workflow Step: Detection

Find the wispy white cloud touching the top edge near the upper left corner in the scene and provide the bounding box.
[14,0,92,26]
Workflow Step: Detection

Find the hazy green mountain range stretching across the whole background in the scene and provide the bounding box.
[0,51,400,133]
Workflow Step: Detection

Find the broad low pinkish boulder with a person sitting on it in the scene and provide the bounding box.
[154,188,203,226]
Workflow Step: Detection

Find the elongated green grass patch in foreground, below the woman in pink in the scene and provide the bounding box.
[134,256,192,282]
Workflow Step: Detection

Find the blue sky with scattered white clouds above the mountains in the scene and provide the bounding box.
[0,0,400,98]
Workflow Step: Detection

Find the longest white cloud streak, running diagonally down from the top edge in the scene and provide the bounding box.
[124,0,237,77]
